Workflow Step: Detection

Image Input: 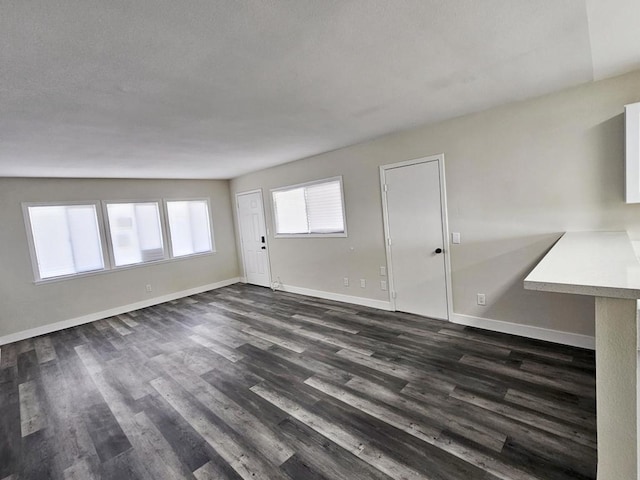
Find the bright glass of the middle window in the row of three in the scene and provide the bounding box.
[107,202,165,267]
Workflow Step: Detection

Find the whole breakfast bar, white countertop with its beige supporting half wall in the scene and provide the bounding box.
[524,232,640,480]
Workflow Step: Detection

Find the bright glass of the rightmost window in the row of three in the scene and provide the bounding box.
[166,200,213,257]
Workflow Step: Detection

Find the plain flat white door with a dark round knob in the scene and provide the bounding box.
[381,157,448,320]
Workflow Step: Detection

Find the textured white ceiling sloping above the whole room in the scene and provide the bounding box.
[0,0,640,178]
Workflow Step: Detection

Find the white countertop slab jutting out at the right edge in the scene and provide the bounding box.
[524,232,640,299]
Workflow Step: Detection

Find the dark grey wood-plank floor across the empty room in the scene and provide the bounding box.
[0,284,597,480]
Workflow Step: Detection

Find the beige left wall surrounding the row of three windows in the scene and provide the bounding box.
[0,178,238,337]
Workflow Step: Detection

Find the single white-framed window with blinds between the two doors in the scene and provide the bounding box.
[271,177,346,237]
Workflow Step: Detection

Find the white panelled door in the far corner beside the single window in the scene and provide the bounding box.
[236,191,271,287]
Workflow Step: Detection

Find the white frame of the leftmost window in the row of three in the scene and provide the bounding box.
[22,200,112,283]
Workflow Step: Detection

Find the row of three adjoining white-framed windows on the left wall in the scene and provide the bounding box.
[22,198,215,282]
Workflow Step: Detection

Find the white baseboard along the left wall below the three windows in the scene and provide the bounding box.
[0,277,240,345]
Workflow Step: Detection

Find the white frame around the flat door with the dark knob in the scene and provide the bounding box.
[380,153,453,322]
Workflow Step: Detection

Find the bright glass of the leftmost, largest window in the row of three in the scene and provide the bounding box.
[27,205,104,279]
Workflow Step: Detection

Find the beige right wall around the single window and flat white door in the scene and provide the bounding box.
[231,68,640,336]
